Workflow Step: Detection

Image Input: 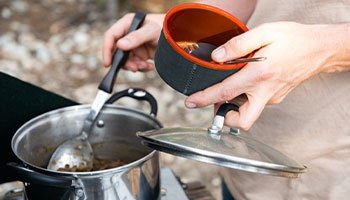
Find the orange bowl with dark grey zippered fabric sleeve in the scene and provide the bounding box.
[154,3,253,95]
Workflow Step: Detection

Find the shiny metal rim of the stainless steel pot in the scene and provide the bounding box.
[11,104,163,176]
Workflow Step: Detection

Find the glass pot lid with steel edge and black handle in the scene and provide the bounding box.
[137,104,306,178]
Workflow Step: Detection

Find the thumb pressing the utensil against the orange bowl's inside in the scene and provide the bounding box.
[211,28,270,62]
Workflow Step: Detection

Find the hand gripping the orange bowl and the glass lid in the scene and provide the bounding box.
[185,22,349,130]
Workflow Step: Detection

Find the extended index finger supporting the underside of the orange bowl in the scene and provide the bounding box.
[185,69,251,108]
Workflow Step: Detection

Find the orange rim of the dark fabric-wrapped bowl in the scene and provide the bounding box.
[163,3,254,70]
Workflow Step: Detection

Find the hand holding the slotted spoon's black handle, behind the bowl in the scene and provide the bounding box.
[103,13,164,72]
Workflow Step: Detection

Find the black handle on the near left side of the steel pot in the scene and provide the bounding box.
[7,162,74,188]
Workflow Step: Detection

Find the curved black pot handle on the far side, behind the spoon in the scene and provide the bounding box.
[106,88,158,117]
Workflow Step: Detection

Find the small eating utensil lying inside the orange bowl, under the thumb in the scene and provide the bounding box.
[181,42,266,64]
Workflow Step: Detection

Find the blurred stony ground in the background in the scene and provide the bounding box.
[0,0,221,199]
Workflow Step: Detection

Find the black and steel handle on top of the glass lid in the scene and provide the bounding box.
[208,103,239,136]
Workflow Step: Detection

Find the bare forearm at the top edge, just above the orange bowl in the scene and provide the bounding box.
[197,0,257,24]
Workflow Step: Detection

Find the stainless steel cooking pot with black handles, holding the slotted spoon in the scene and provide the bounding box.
[8,88,162,200]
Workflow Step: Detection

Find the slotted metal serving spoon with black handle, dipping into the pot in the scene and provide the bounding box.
[47,11,146,171]
